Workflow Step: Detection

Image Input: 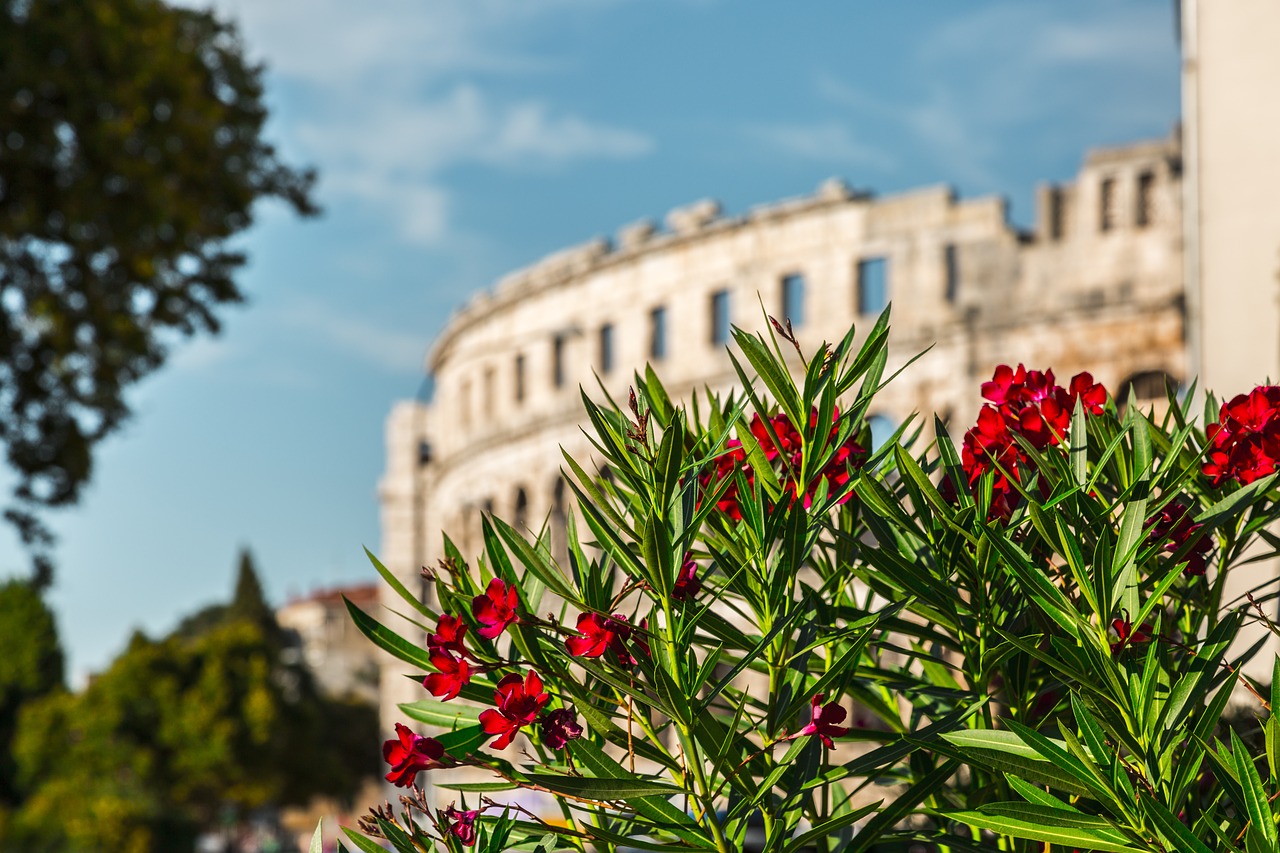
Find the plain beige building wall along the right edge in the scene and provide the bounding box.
[1181,0,1280,681]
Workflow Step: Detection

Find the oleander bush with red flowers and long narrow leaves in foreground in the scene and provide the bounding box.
[347,314,1280,853]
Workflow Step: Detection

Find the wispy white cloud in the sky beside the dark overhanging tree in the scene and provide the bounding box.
[180,0,654,243]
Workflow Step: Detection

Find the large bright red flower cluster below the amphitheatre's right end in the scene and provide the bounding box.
[961,364,1107,519]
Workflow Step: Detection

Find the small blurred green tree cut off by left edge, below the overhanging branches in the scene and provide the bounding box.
[0,580,63,809]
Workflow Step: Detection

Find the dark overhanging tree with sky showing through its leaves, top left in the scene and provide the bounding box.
[0,0,316,575]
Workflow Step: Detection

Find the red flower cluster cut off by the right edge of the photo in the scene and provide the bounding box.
[1202,386,1280,485]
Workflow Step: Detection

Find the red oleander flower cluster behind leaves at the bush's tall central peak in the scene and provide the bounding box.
[700,409,867,521]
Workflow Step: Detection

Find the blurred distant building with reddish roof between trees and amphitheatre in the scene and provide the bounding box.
[275,584,381,704]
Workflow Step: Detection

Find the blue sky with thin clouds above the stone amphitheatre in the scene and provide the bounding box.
[0,0,1178,680]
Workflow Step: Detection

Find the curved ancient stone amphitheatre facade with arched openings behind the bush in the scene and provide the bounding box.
[380,137,1188,727]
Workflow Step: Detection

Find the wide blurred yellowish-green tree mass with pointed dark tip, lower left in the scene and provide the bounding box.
[8,555,378,853]
